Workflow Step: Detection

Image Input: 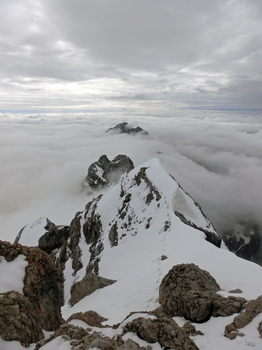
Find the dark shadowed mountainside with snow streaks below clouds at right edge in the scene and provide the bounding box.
[222,219,261,260]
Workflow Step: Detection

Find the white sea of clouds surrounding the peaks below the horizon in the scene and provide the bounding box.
[0,111,262,241]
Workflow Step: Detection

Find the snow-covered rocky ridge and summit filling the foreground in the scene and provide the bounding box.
[0,159,262,350]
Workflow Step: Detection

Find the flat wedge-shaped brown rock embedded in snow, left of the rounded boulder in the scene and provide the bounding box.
[69,273,116,305]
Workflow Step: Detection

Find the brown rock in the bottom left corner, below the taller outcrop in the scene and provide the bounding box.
[0,291,44,346]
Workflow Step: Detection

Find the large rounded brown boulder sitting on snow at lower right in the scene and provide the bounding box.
[159,264,220,322]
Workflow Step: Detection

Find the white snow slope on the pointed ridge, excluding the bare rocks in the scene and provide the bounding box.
[0,159,262,350]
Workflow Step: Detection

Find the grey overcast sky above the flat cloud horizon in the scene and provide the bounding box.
[0,0,262,115]
